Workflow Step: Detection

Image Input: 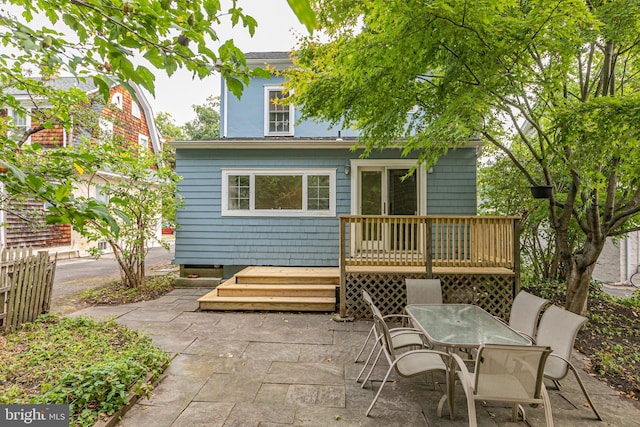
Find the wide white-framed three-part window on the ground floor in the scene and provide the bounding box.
[222,169,336,216]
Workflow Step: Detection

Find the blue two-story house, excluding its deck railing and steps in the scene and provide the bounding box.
[174,52,478,276]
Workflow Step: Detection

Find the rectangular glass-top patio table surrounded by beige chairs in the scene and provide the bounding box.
[406,304,531,419]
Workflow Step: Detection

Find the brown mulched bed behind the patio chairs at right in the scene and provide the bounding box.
[522,281,640,400]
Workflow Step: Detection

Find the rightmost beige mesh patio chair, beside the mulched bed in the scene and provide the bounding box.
[536,305,602,421]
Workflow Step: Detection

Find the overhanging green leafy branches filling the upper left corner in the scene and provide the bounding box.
[0,0,315,231]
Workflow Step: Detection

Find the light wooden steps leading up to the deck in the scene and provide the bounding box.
[198,267,340,311]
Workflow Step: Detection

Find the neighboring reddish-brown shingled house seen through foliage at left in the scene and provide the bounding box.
[0,77,162,253]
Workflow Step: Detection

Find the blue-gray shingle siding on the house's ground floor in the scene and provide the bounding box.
[175,147,476,266]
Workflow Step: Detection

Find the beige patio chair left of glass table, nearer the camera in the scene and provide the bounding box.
[365,314,450,417]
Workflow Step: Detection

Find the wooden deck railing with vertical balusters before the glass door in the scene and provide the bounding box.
[340,215,519,273]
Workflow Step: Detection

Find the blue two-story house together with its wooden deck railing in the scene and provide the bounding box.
[173,52,513,318]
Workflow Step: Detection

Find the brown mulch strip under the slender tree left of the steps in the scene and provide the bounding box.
[80,274,175,305]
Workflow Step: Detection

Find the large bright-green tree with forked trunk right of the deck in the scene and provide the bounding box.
[289,0,640,313]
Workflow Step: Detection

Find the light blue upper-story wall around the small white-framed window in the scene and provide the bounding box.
[220,76,357,138]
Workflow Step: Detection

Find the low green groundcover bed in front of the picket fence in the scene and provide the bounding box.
[0,314,170,426]
